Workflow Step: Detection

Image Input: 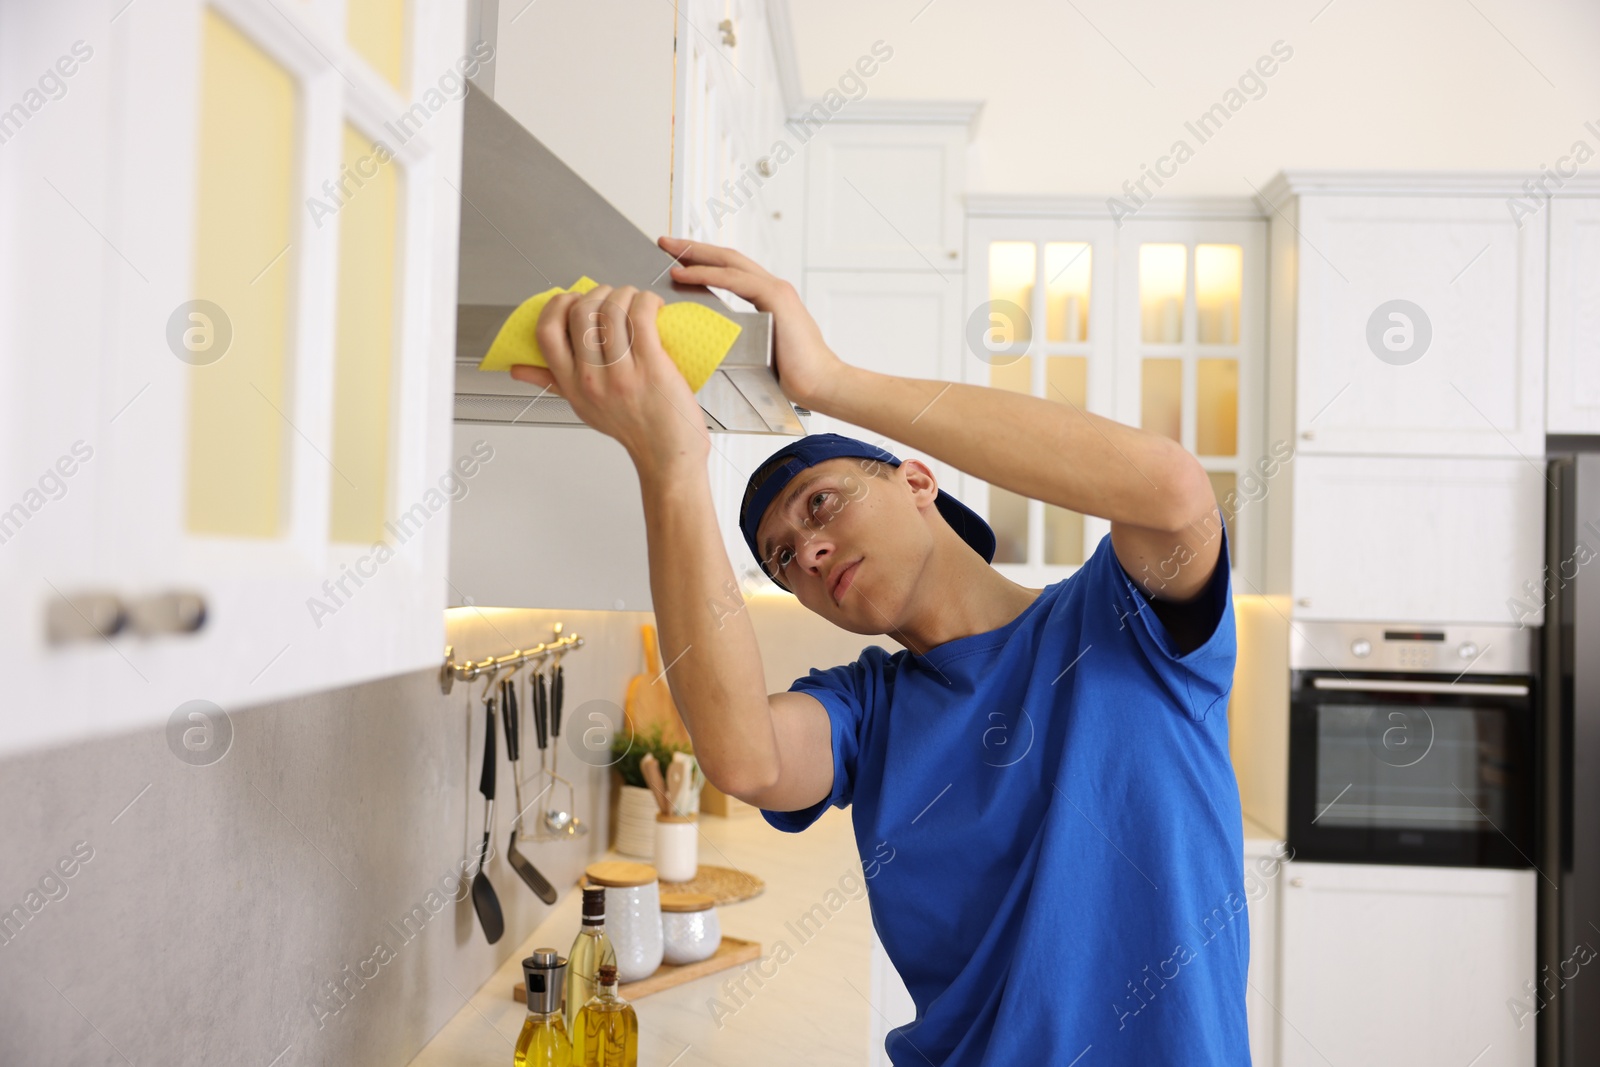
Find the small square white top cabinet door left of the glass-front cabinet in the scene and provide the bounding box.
[800,121,966,274]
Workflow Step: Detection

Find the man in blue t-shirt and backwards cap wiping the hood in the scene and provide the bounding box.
[514,238,1250,1067]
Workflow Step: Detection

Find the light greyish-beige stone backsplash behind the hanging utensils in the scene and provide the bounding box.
[0,597,876,1067]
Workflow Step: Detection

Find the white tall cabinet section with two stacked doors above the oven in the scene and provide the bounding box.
[1262,171,1548,625]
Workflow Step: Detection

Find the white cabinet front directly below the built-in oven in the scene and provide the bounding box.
[1278,862,1538,1067]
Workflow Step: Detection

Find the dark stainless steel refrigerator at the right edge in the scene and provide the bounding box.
[1520,453,1600,1067]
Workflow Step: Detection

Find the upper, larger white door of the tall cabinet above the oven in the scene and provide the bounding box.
[1296,195,1546,456]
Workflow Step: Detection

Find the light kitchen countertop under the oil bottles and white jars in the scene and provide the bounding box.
[411,808,872,1067]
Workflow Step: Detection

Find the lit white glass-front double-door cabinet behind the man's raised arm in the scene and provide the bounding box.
[962,206,1272,592]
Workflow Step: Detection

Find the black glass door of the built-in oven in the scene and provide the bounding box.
[1290,678,1533,867]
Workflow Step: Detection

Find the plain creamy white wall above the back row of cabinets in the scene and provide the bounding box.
[789,0,1600,197]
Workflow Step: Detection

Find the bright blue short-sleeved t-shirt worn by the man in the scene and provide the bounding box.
[762,531,1250,1067]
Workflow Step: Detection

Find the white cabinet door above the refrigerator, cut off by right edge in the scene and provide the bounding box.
[1548,198,1600,434]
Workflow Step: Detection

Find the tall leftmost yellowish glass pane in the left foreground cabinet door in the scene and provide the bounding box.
[186,6,299,537]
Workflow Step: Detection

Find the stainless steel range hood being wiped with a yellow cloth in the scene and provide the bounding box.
[456,83,805,435]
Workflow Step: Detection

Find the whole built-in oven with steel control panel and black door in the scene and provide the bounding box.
[1288,621,1538,867]
